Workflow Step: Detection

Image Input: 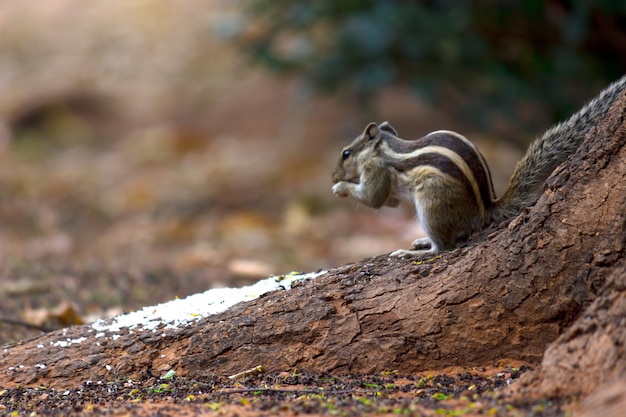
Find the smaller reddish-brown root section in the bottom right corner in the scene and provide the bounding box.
[512,262,626,417]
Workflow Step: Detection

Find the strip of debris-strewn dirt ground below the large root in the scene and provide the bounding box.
[0,366,570,416]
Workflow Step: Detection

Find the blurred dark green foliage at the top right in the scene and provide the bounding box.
[228,0,626,127]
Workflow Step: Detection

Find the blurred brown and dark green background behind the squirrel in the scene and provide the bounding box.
[0,0,626,343]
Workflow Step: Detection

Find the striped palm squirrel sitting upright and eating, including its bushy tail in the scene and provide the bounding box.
[332,76,626,257]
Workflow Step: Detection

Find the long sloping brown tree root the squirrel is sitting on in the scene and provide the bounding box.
[0,92,626,396]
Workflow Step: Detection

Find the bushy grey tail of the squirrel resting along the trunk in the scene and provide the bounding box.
[491,76,626,221]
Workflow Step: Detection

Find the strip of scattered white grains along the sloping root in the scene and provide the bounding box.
[91,271,327,337]
